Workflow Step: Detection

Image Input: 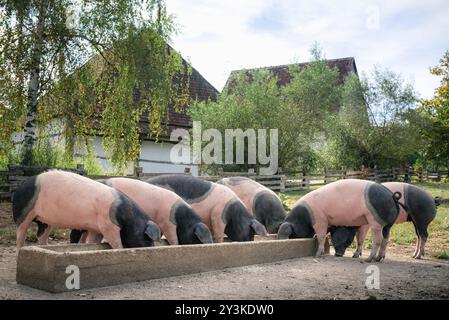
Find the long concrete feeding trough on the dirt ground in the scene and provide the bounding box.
[16,235,329,293]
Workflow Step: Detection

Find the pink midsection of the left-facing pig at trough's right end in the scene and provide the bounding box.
[298,179,374,226]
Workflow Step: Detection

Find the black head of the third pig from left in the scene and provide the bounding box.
[222,200,267,241]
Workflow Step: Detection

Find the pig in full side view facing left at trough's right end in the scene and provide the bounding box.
[278,179,402,262]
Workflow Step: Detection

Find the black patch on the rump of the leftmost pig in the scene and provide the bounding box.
[12,176,39,225]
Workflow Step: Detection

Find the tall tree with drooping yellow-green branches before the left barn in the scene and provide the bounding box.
[0,0,189,168]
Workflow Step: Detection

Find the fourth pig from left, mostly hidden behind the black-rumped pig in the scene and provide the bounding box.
[217,177,286,233]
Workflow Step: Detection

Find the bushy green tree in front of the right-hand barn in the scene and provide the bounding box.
[189,47,339,170]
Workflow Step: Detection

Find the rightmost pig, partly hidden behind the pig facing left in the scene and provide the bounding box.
[348,182,440,259]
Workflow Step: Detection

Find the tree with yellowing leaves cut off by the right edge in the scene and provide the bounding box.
[420,51,449,168]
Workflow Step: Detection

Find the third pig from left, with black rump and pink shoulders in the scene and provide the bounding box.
[146,174,267,242]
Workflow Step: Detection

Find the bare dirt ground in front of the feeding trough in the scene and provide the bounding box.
[0,202,449,300]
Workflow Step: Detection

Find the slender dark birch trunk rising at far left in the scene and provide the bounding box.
[22,0,45,165]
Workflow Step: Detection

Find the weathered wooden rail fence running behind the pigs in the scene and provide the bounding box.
[0,165,449,201]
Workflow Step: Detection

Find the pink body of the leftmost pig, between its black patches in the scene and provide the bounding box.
[33,170,116,232]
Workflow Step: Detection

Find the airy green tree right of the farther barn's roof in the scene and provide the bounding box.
[324,68,423,168]
